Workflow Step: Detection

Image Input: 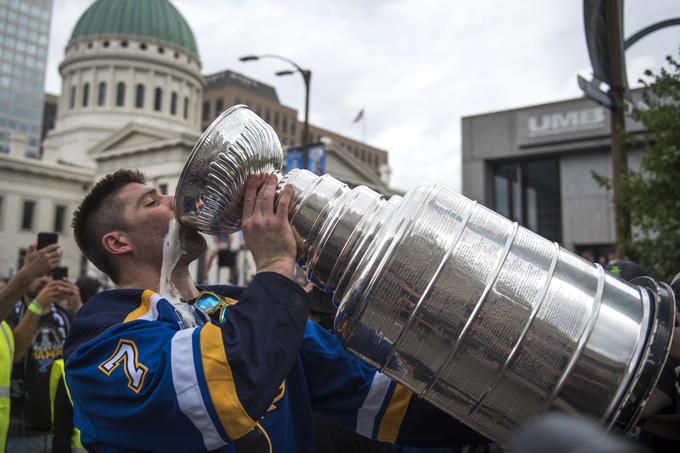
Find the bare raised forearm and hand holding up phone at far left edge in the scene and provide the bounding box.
[0,244,61,320]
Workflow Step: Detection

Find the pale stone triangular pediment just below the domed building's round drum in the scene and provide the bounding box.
[88,122,199,160]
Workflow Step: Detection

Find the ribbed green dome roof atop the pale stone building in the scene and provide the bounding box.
[71,0,198,56]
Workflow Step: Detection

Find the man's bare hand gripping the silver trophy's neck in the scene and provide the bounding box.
[241,174,297,278]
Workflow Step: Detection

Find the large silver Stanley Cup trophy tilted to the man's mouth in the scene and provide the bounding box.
[175,106,675,443]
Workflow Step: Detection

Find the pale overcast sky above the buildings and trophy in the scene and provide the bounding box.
[46,0,680,191]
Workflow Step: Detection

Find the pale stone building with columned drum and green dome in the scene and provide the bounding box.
[0,0,204,278]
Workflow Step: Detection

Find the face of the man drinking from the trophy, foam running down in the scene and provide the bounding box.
[117,183,206,268]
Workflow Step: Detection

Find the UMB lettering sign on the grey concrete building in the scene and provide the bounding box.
[527,107,606,137]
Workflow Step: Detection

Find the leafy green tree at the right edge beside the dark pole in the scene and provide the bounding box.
[594,56,680,281]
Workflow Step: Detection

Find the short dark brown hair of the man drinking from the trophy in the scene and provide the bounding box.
[71,170,146,283]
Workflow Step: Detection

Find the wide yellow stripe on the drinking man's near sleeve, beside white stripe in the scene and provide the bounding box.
[200,324,255,440]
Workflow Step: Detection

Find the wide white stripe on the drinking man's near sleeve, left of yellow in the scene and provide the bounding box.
[170,324,226,450]
